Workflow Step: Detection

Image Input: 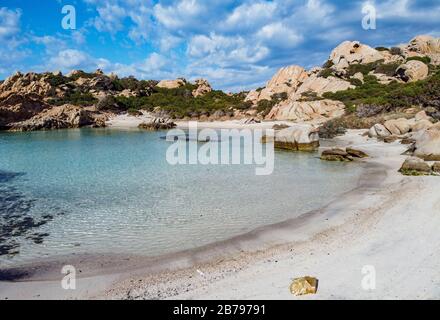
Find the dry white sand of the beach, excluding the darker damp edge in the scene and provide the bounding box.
[104,131,440,299]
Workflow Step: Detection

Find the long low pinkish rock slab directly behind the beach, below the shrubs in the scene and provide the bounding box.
[266,100,345,124]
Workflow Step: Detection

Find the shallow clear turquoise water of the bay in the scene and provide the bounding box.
[0,129,362,265]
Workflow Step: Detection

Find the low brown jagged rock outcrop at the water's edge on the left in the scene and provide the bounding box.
[11,105,96,131]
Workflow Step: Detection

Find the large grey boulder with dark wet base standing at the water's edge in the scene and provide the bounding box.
[263,124,319,151]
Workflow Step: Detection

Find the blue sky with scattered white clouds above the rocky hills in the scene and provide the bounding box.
[0,0,440,91]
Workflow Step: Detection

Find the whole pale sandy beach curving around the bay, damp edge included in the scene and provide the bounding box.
[0,124,440,299]
